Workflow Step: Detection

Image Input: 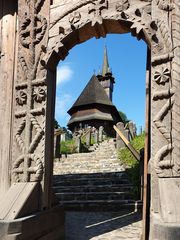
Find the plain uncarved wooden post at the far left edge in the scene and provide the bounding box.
[0,0,17,200]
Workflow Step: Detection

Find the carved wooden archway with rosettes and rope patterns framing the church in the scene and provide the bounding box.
[0,0,180,240]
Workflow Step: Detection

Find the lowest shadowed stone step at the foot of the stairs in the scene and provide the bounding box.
[57,200,142,212]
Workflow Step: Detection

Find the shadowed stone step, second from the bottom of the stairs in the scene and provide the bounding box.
[56,192,133,202]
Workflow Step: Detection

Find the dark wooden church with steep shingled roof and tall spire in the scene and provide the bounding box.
[67,47,122,136]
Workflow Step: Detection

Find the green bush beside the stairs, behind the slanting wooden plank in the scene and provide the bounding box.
[119,133,145,199]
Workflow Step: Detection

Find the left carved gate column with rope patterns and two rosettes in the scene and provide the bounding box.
[12,0,55,207]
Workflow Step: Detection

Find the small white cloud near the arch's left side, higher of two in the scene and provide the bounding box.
[57,65,73,85]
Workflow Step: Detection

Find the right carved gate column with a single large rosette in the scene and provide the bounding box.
[150,0,180,240]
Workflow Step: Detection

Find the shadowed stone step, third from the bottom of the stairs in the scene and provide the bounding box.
[53,184,133,194]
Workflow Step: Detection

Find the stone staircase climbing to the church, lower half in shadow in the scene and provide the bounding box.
[54,139,139,211]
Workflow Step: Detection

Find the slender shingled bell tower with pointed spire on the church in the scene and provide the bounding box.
[97,46,115,101]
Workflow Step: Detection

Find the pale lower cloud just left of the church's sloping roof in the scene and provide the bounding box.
[55,93,74,126]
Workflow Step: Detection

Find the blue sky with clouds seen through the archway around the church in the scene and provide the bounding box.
[55,34,147,132]
